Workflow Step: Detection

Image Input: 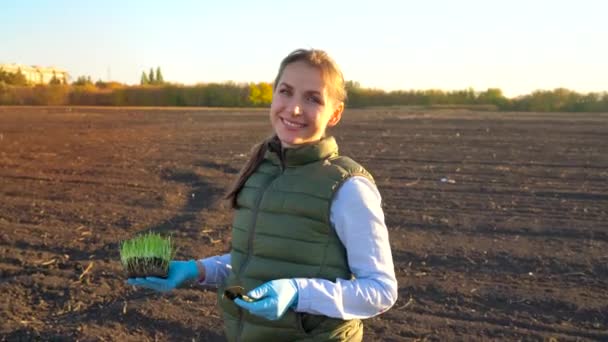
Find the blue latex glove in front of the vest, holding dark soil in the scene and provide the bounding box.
[234,279,298,321]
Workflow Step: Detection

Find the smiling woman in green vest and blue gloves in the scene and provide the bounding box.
[129,50,397,341]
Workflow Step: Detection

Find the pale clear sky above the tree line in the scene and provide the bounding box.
[0,0,608,97]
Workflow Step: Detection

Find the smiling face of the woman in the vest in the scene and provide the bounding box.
[270,61,344,147]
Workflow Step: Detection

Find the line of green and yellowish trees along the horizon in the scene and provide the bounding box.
[0,67,608,112]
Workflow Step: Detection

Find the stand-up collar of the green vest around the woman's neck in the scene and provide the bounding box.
[264,136,338,167]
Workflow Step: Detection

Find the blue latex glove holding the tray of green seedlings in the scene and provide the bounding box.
[127,260,199,292]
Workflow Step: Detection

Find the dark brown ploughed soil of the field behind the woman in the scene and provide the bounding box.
[0,107,608,341]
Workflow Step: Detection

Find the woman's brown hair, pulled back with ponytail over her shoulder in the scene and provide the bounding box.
[224,49,346,208]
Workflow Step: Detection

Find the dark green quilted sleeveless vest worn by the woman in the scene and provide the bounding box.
[218,137,373,341]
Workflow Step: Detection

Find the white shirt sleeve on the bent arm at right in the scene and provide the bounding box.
[296,176,397,319]
